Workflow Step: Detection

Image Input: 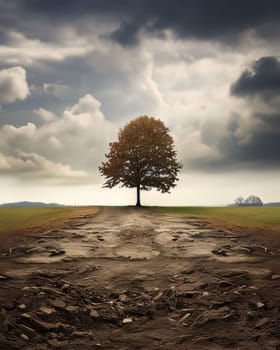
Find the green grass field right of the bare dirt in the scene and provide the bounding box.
[154,207,280,232]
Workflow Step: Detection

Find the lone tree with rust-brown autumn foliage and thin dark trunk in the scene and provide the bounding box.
[99,116,182,207]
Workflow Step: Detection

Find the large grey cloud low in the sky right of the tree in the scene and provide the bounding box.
[194,113,280,172]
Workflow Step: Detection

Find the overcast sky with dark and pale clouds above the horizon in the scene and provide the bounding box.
[0,0,280,205]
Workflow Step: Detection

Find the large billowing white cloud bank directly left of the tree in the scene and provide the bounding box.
[0,95,117,184]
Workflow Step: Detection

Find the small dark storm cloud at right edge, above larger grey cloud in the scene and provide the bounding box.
[231,57,280,97]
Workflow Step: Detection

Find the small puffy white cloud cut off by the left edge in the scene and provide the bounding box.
[0,67,29,104]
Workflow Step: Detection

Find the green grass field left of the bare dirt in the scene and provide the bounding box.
[0,207,98,235]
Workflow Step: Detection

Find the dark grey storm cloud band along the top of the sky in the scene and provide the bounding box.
[7,0,280,45]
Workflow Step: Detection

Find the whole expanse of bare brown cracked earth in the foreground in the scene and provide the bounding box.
[0,208,280,350]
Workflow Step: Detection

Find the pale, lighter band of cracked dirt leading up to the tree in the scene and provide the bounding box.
[9,208,269,263]
